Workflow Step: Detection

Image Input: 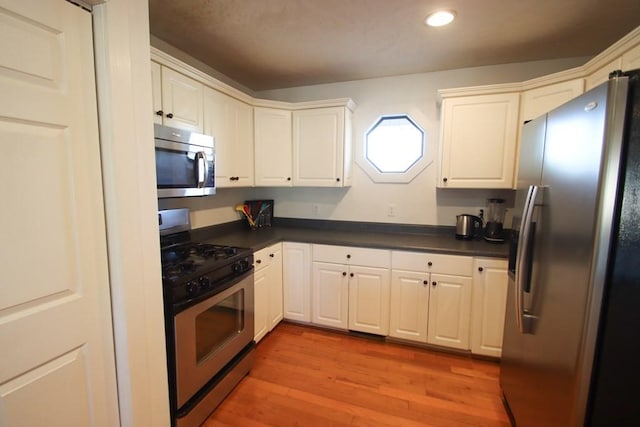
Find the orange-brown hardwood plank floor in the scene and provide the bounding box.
[204,322,509,427]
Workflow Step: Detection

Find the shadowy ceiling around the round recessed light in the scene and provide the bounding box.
[149,0,640,91]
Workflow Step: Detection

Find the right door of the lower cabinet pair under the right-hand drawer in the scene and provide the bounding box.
[427,274,472,350]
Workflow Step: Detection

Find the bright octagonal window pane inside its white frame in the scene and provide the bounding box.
[364,115,424,174]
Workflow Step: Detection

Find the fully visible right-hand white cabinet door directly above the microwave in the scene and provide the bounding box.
[162,67,204,132]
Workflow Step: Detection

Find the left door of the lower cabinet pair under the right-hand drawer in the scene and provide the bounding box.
[389,270,430,343]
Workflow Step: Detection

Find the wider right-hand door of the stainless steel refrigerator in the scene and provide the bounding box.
[506,81,608,427]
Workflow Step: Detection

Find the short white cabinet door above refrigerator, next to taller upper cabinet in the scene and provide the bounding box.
[520,79,584,123]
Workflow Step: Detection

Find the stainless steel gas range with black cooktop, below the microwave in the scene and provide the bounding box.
[158,209,255,427]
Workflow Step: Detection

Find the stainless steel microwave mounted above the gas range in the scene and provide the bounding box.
[154,124,216,198]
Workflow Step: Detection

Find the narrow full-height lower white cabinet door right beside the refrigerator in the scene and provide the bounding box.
[471,258,508,357]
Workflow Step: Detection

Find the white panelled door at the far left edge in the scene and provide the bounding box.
[0,0,119,427]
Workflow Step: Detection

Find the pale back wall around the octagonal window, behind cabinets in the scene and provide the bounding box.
[160,58,587,228]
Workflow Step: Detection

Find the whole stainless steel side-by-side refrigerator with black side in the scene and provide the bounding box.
[500,72,640,427]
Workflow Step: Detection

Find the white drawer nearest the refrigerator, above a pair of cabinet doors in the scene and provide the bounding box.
[391,251,473,276]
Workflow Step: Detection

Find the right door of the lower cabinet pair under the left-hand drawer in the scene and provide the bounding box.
[349,266,390,336]
